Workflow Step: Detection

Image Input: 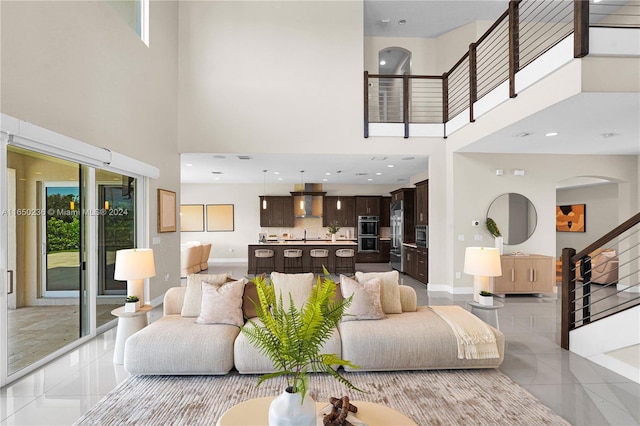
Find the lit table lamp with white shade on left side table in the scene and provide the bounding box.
[113,248,156,303]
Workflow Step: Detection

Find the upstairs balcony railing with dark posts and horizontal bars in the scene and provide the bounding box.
[364,0,640,138]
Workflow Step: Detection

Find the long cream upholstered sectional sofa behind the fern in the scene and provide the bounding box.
[124,271,504,375]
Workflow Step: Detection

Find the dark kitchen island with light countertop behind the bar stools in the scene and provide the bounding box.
[248,240,358,275]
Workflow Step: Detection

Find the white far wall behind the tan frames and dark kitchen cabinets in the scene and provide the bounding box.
[180,183,399,262]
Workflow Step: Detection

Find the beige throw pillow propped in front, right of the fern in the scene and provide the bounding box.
[340,275,385,322]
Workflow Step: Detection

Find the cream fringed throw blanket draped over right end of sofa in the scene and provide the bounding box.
[429,306,500,359]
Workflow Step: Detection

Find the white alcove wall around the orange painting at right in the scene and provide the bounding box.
[556,183,628,257]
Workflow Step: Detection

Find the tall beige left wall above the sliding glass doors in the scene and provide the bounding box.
[0,1,180,298]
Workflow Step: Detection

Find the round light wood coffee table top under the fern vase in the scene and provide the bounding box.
[216,396,418,426]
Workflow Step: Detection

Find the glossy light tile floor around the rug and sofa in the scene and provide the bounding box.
[0,264,640,425]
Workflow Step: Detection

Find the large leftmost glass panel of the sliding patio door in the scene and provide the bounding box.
[6,146,89,375]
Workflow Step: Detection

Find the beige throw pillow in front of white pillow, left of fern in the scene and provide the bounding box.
[196,279,245,327]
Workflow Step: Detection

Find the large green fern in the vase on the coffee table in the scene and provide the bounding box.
[242,269,360,400]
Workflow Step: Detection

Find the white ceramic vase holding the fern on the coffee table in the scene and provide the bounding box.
[269,390,316,426]
